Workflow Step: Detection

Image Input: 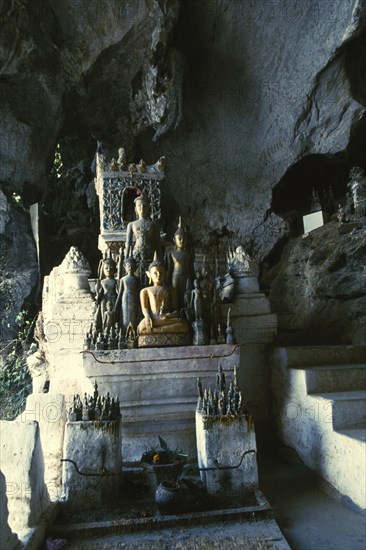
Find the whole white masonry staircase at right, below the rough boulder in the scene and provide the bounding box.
[272,346,366,509]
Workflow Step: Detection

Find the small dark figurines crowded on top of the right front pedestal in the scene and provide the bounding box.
[197,365,248,416]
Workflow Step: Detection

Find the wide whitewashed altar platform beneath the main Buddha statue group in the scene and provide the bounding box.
[82,344,240,462]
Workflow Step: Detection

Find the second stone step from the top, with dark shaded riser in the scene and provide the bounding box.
[305,364,366,394]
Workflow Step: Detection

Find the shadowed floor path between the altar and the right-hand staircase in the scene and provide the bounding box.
[258,447,366,550]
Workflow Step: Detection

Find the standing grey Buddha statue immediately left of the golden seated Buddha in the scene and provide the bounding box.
[115,257,142,330]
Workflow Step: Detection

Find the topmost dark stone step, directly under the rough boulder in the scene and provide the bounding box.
[285,345,366,368]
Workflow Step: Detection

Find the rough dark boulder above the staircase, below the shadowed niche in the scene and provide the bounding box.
[264,222,366,344]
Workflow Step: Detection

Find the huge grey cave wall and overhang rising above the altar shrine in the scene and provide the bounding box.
[0,0,366,340]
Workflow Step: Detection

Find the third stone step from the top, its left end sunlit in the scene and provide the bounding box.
[312,391,366,430]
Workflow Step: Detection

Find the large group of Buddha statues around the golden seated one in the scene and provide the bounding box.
[85,194,237,349]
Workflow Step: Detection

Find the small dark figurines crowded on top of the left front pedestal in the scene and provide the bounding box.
[69,381,121,422]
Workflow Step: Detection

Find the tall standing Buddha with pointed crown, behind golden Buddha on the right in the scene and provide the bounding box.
[168,217,193,309]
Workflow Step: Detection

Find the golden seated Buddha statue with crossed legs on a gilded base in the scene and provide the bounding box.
[137,258,189,335]
